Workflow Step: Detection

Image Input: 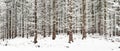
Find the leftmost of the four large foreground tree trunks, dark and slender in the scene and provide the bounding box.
[34,0,37,44]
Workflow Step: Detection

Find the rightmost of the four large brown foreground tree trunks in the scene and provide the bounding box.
[82,0,86,39]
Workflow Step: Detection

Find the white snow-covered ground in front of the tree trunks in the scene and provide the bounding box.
[0,34,120,51]
